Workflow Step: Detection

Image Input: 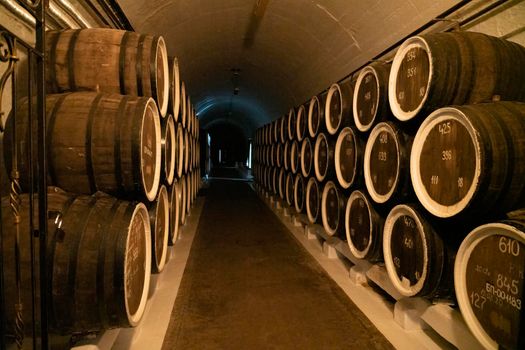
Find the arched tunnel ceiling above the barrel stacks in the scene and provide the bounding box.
[118,0,460,135]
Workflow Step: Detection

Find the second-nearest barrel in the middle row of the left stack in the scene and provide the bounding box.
[160,114,177,185]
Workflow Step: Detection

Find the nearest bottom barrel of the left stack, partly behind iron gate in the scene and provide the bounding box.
[2,187,151,335]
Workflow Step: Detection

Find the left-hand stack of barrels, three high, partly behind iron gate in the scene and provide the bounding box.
[2,29,200,334]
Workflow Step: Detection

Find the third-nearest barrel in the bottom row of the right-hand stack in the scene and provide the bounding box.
[345,190,384,262]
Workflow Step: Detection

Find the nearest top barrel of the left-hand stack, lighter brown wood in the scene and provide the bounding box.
[45,28,170,117]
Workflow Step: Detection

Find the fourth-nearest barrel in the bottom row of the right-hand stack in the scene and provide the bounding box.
[321,181,346,236]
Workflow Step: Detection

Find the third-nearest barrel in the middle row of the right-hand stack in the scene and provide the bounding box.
[334,126,365,190]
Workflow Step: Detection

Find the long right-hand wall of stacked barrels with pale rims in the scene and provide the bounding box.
[254,32,525,349]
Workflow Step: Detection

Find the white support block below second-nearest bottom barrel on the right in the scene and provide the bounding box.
[394,298,430,331]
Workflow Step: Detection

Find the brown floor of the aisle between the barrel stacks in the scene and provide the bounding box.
[163,176,392,349]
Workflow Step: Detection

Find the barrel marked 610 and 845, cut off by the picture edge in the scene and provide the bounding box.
[454,218,525,350]
